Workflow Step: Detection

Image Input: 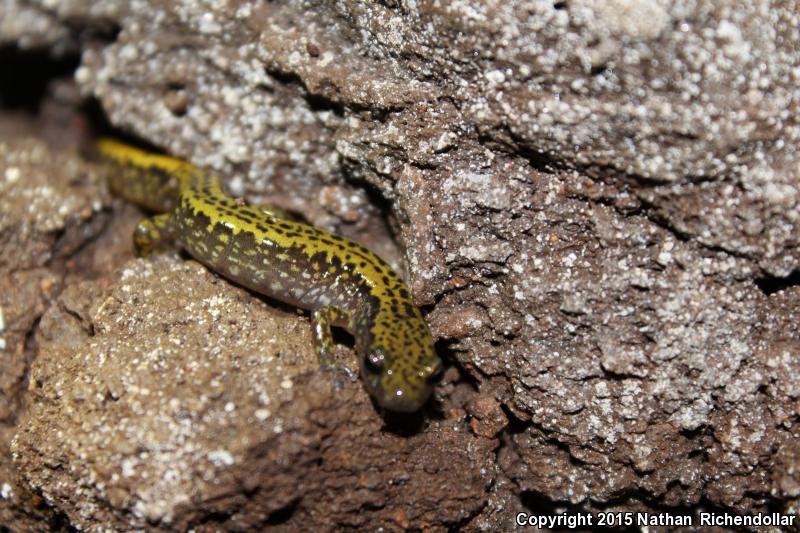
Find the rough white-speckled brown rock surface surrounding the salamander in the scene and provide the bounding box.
[0,0,800,531]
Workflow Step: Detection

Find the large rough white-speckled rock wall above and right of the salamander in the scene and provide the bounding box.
[0,0,800,530]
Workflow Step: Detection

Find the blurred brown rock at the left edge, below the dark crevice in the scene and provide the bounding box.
[0,138,109,531]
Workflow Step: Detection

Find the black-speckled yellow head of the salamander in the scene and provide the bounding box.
[358,311,442,413]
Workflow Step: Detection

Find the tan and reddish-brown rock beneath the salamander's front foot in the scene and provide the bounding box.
[13,257,495,531]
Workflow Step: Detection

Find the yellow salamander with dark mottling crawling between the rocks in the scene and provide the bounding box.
[97,139,441,412]
